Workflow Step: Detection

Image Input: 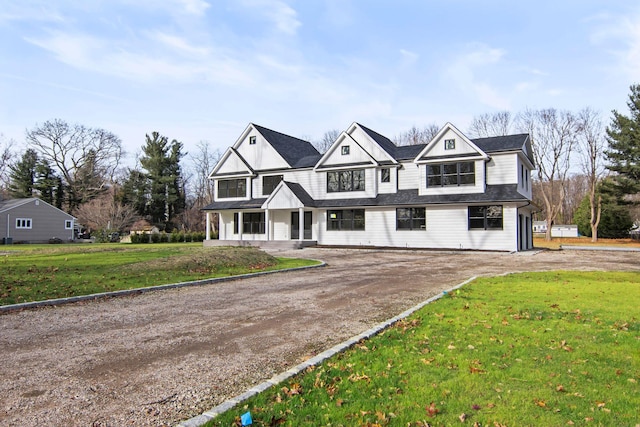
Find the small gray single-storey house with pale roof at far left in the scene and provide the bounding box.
[0,197,76,244]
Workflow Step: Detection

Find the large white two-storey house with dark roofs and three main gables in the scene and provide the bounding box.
[204,123,534,251]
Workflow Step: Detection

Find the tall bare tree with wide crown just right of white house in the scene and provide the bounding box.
[517,108,578,240]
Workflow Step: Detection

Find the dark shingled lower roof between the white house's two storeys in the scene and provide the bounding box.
[203,182,529,210]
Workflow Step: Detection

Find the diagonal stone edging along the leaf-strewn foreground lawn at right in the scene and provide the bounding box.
[176,276,477,427]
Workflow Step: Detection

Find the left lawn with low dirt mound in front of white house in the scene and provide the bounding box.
[0,243,317,305]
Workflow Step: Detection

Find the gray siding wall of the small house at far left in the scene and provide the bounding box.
[0,200,74,243]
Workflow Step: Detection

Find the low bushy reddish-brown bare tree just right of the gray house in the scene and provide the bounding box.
[73,188,137,232]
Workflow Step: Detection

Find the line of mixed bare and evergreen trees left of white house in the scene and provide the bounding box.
[0,119,220,236]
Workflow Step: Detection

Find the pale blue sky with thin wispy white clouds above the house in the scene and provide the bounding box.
[0,0,640,167]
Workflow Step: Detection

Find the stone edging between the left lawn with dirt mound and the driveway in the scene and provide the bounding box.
[0,260,327,313]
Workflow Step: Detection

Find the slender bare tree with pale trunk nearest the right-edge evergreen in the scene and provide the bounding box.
[578,107,606,242]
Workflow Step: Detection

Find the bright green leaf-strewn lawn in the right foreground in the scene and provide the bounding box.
[207,272,640,427]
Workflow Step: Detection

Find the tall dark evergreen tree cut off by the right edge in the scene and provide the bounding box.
[606,84,640,197]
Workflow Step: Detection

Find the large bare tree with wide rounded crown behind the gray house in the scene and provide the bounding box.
[27,119,123,212]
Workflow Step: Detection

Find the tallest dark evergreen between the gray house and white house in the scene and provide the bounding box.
[140,132,185,229]
